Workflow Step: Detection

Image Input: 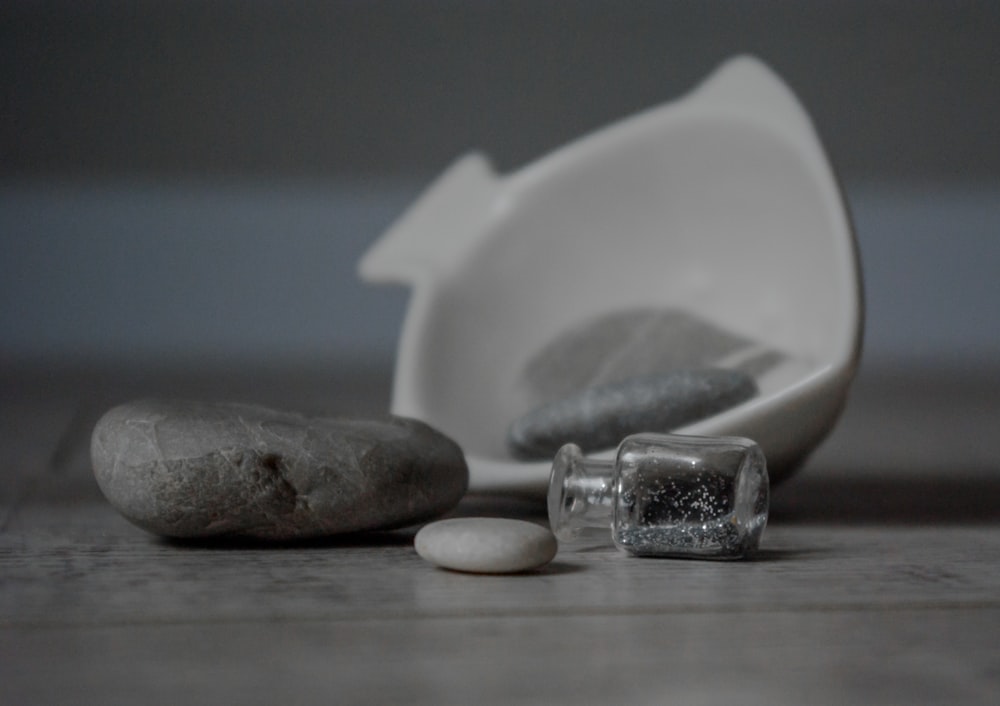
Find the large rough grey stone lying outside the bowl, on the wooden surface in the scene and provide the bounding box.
[91,400,468,540]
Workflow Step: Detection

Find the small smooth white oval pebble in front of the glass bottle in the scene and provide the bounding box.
[413,517,558,574]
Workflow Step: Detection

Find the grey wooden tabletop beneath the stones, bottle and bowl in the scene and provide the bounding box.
[0,366,1000,704]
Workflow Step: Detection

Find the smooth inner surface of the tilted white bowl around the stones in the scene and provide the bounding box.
[416,116,857,461]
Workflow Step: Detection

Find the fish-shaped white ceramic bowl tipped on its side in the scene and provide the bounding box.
[360,57,862,491]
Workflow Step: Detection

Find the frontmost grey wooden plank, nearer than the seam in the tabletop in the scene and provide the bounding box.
[0,608,1000,705]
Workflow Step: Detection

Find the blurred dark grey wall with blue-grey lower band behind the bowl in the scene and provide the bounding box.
[0,0,1000,365]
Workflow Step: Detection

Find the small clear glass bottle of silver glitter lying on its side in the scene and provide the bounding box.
[548,434,769,559]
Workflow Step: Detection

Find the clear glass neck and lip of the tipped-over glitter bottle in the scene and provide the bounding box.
[548,444,615,541]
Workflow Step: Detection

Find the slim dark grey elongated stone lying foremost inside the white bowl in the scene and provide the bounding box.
[507,368,757,459]
